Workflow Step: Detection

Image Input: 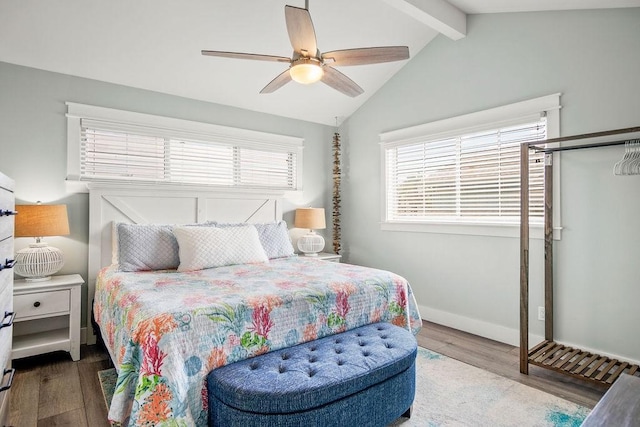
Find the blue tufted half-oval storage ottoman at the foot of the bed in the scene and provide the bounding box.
[207,323,417,427]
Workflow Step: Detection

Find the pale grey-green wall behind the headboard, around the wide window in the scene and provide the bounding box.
[0,62,334,328]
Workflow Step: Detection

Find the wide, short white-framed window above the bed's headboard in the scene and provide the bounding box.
[68,103,302,190]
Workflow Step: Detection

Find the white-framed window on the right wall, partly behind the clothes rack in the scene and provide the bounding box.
[381,95,559,234]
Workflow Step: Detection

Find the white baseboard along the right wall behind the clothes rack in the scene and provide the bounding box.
[418,305,640,364]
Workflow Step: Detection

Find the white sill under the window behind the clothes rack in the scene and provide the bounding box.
[380,222,562,240]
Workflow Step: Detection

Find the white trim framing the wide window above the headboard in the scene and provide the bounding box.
[66,102,304,196]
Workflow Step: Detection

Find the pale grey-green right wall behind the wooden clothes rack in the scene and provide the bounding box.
[340,8,640,361]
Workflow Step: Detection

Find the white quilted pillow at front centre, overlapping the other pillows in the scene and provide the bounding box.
[173,225,269,271]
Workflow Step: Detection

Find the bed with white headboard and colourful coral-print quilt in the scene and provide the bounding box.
[89,188,421,426]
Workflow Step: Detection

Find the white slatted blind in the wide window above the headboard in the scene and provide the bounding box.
[79,119,301,190]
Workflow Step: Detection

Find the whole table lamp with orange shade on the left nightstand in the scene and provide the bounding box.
[14,202,69,282]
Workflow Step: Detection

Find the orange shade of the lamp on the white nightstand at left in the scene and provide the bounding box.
[15,205,69,237]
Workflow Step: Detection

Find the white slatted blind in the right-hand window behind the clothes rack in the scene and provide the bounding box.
[385,118,546,223]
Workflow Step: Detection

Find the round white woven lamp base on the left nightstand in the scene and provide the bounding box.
[14,242,64,282]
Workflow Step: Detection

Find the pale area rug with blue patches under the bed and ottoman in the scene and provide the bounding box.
[98,348,589,427]
